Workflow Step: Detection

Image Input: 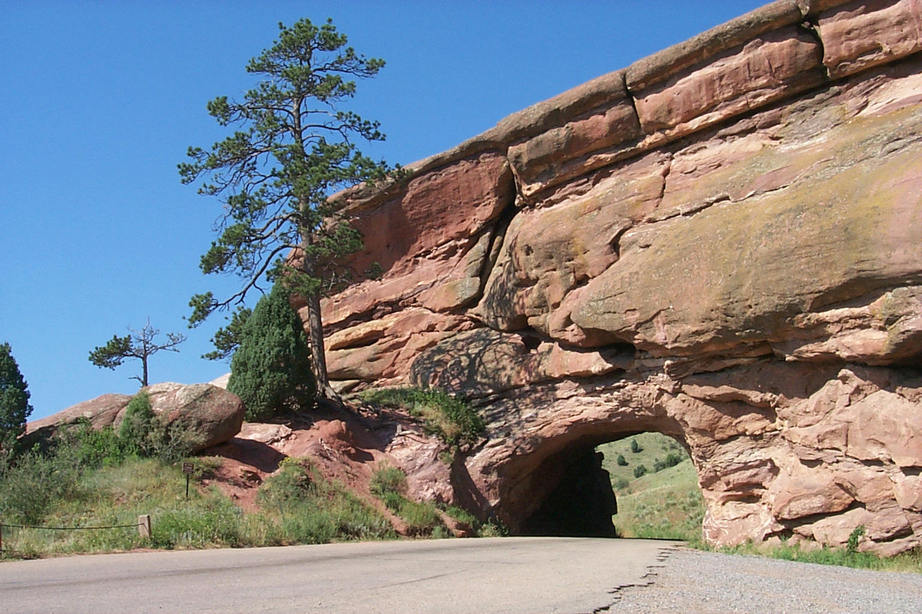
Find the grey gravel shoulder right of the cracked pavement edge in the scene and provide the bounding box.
[607,548,922,614]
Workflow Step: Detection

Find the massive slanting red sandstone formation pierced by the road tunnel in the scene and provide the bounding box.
[324,0,922,554]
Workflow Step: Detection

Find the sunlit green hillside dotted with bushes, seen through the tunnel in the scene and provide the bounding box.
[596,433,704,542]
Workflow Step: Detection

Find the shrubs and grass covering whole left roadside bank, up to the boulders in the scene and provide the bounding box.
[0,395,396,558]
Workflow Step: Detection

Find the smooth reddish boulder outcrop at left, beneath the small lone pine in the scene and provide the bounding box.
[23,382,245,454]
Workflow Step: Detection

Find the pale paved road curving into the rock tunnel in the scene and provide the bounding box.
[0,537,671,614]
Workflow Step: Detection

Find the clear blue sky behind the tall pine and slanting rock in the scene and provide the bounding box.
[0,0,762,419]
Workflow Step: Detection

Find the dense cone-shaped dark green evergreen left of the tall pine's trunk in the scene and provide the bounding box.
[227,284,317,420]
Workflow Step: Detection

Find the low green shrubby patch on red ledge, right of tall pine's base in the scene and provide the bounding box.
[361,388,486,447]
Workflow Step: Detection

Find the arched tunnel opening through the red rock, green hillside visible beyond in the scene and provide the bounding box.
[517,431,704,541]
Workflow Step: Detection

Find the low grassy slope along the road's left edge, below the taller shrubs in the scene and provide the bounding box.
[3,458,396,558]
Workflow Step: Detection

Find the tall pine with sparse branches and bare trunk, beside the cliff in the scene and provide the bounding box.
[179,19,393,398]
